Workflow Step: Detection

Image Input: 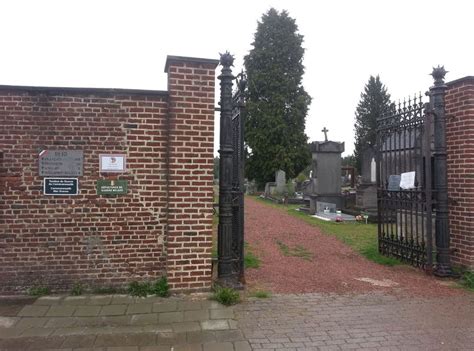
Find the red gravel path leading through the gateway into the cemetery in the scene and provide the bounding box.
[245,197,464,296]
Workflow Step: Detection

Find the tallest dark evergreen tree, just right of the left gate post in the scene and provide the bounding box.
[244,9,311,185]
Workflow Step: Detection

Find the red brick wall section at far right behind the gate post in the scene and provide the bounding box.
[446,77,474,269]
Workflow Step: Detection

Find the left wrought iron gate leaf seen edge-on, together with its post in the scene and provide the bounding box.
[217,53,246,288]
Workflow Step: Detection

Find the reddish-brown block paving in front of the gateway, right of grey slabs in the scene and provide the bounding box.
[236,294,474,351]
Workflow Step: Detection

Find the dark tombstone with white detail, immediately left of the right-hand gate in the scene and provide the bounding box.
[356,146,377,214]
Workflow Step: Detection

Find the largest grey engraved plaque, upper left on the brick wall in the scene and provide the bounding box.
[39,150,84,177]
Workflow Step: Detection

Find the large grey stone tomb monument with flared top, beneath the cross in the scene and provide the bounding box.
[305,141,344,214]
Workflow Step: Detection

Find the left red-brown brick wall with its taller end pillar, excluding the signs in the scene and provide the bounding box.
[0,56,217,293]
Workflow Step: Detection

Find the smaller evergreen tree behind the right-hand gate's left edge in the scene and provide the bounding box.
[354,76,392,172]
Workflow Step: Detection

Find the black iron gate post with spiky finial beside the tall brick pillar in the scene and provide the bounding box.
[217,52,238,287]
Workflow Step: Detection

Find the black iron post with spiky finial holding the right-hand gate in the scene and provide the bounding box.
[429,66,453,277]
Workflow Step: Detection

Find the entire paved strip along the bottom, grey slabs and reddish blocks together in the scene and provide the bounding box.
[0,293,474,351]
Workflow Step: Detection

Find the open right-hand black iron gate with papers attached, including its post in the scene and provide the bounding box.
[377,66,453,276]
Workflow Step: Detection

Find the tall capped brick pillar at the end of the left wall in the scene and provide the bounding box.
[165,56,219,291]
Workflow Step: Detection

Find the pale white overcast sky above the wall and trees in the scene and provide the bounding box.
[0,0,474,154]
